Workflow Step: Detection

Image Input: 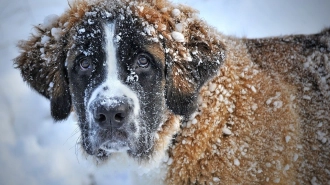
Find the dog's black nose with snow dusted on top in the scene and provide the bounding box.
[93,98,132,129]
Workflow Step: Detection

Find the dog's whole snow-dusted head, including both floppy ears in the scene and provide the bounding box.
[15,1,224,162]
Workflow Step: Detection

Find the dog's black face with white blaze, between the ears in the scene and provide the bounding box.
[67,19,167,157]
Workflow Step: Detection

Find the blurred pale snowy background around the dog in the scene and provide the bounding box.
[0,0,330,185]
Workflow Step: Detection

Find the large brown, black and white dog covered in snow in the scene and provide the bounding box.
[15,0,330,184]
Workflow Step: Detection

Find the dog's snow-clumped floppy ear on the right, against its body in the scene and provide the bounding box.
[165,20,225,116]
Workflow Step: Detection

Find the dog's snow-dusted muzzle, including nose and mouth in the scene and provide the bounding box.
[87,96,136,155]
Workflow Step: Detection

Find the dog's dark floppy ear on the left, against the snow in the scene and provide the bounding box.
[14,17,71,121]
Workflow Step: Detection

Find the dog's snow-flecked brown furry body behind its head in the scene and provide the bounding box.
[168,30,330,184]
